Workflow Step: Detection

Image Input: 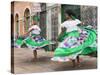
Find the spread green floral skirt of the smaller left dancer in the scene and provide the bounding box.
[15,34,54,50]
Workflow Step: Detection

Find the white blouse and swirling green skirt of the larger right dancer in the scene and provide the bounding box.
[51,19,96,62]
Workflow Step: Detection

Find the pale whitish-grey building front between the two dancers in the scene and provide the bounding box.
[46,4,61,50]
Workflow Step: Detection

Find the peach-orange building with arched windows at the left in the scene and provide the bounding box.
[11,1,40,36]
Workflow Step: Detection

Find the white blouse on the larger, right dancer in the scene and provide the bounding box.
[61,19,81,32]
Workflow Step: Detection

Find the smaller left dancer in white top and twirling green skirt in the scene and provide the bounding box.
[16,15,53,60]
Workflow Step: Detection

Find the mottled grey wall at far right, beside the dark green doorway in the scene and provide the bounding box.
[80,6,97,30]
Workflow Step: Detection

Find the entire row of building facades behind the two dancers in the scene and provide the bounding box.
[11,1,97,50]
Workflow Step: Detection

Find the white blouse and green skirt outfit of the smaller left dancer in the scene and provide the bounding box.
[16,25,53,50]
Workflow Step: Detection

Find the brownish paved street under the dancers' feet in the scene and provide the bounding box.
[14,48,97,74]
